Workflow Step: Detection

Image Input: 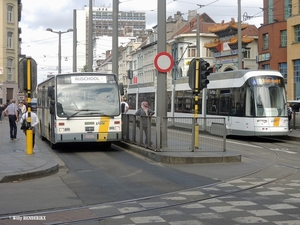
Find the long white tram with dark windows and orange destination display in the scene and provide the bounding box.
[127,70,289,136]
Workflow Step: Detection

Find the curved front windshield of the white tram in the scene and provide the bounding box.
[250,76,287,117]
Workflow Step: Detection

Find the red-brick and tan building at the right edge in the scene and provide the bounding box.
[257,0,300,100]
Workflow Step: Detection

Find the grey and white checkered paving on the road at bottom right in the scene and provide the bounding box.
[90,175,300,225]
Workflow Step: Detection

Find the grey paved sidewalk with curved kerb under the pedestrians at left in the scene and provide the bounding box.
[0,117,59,183]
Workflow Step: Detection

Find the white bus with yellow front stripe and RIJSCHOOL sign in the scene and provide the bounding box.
[37,72,123,149]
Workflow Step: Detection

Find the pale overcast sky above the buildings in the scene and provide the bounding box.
[20,0,263,82]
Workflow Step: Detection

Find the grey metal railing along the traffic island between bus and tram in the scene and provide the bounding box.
[122,114,226,151]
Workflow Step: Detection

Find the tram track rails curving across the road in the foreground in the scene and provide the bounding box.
[0,149,300,225]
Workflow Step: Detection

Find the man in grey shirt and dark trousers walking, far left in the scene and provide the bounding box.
[4,99,19,141]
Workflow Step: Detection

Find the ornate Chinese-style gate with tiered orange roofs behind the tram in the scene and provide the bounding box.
[204,18,254,72]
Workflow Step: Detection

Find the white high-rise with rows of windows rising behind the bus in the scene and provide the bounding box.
[76,7,146,70]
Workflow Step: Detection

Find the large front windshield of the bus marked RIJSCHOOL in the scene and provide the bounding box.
[56,77,120,119]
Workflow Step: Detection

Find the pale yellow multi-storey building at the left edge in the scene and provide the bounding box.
[0,0,22,103]
